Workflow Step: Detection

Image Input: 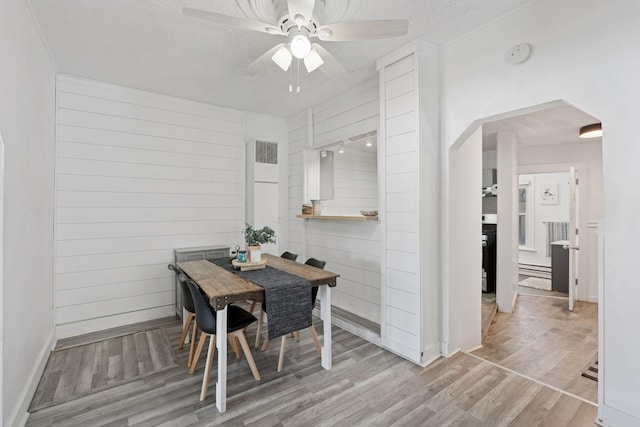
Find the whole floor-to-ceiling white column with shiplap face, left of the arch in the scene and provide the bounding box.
[378,41,443,364]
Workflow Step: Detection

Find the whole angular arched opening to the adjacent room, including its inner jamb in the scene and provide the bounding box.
[449,101,604,402]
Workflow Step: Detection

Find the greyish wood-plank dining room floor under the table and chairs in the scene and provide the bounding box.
[27,312,597,427]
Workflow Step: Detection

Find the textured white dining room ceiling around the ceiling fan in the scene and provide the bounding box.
[30,0,533,117]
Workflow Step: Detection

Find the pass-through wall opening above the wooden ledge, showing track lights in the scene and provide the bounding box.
[305,130,378,215]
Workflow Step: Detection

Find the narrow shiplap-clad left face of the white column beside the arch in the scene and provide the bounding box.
[380,55,421,361]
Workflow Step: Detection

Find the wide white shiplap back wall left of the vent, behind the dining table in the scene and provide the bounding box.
[55,76,244,337]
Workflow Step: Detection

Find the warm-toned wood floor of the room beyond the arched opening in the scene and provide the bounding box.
[473,295,598,403]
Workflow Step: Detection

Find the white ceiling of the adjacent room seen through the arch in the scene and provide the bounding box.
[482,105,602,151]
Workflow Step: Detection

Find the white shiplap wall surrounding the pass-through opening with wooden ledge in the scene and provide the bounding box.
[287,78,381,323]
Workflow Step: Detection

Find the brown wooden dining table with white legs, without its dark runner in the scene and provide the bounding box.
[177,254,339,413]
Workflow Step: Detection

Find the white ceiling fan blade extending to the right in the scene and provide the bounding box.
[316,19,409,42]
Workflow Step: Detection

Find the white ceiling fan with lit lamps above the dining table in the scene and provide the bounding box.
[182,0,409,81]
